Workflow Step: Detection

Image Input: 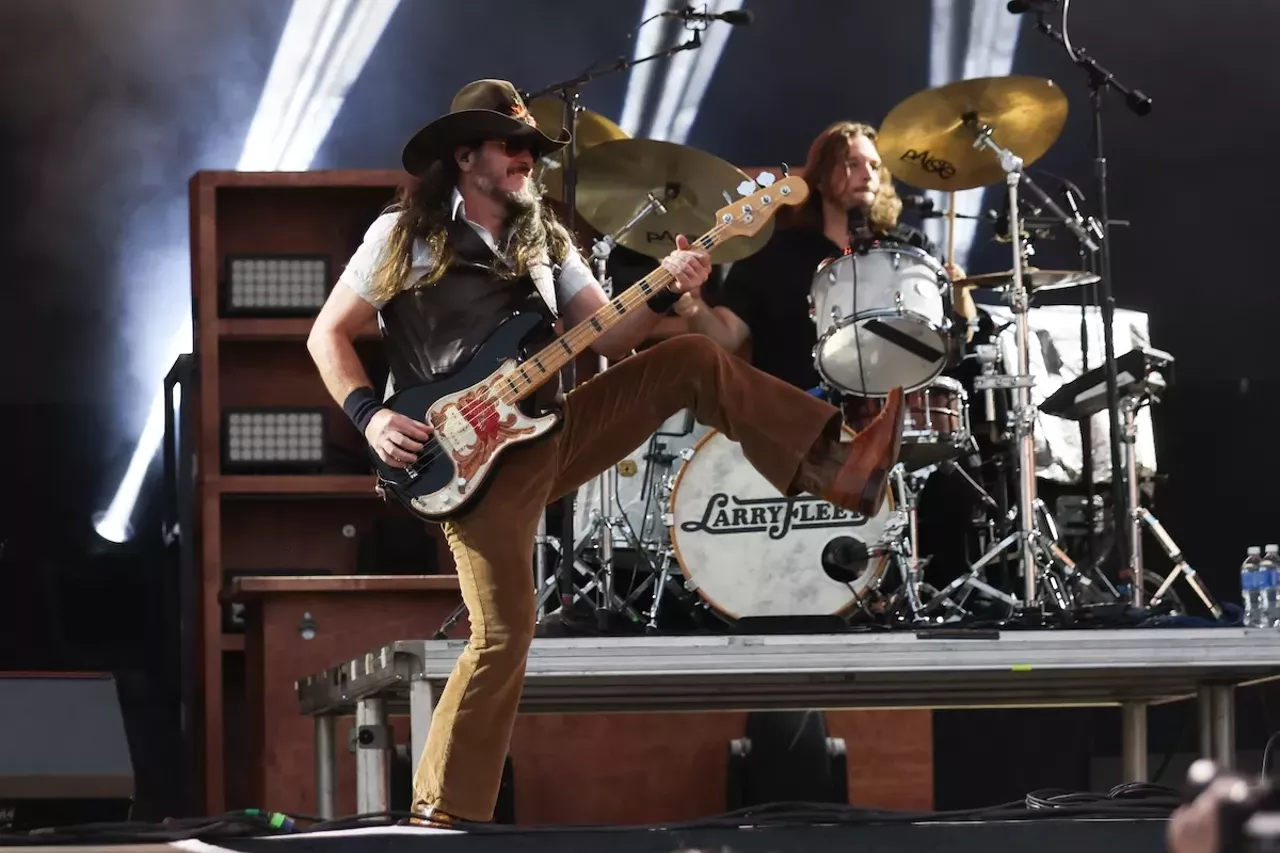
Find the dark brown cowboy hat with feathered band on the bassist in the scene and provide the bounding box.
[401,79,570,175]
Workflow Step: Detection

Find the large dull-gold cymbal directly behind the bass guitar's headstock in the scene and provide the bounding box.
[577,140,773,264]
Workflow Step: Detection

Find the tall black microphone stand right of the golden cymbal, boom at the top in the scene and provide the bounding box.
[1036,13,1151,607]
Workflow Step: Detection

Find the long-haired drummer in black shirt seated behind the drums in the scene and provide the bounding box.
[675,116,977,393]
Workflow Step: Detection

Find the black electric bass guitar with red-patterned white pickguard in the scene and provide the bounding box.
[370,175,809,521]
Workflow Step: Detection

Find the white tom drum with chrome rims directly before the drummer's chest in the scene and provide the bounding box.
[809,246,951,397]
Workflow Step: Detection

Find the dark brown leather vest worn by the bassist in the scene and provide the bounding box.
[380,218,561,409]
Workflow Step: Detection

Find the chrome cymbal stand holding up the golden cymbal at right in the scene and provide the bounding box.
[960,121,1096,611]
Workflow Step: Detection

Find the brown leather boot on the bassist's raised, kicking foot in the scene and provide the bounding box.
[796,388,906,517]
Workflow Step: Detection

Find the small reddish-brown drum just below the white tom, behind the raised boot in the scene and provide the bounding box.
[840,377,970,471]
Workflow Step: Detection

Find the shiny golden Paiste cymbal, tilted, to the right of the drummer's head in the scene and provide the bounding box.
[876,77,1068,191]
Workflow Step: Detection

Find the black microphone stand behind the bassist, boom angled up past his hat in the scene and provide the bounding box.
[521,22,703,612]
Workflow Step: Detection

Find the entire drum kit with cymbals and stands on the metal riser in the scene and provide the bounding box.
[504,77,1216,631]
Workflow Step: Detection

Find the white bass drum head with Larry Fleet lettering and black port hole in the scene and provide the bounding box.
[671,430,892,621]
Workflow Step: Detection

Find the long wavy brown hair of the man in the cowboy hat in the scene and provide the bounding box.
[372,158,577,300]
